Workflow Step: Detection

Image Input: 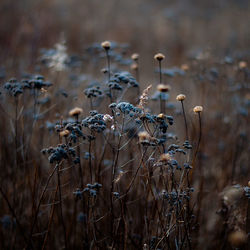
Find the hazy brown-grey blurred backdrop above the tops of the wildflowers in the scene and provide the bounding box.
[0,0,250,71]
